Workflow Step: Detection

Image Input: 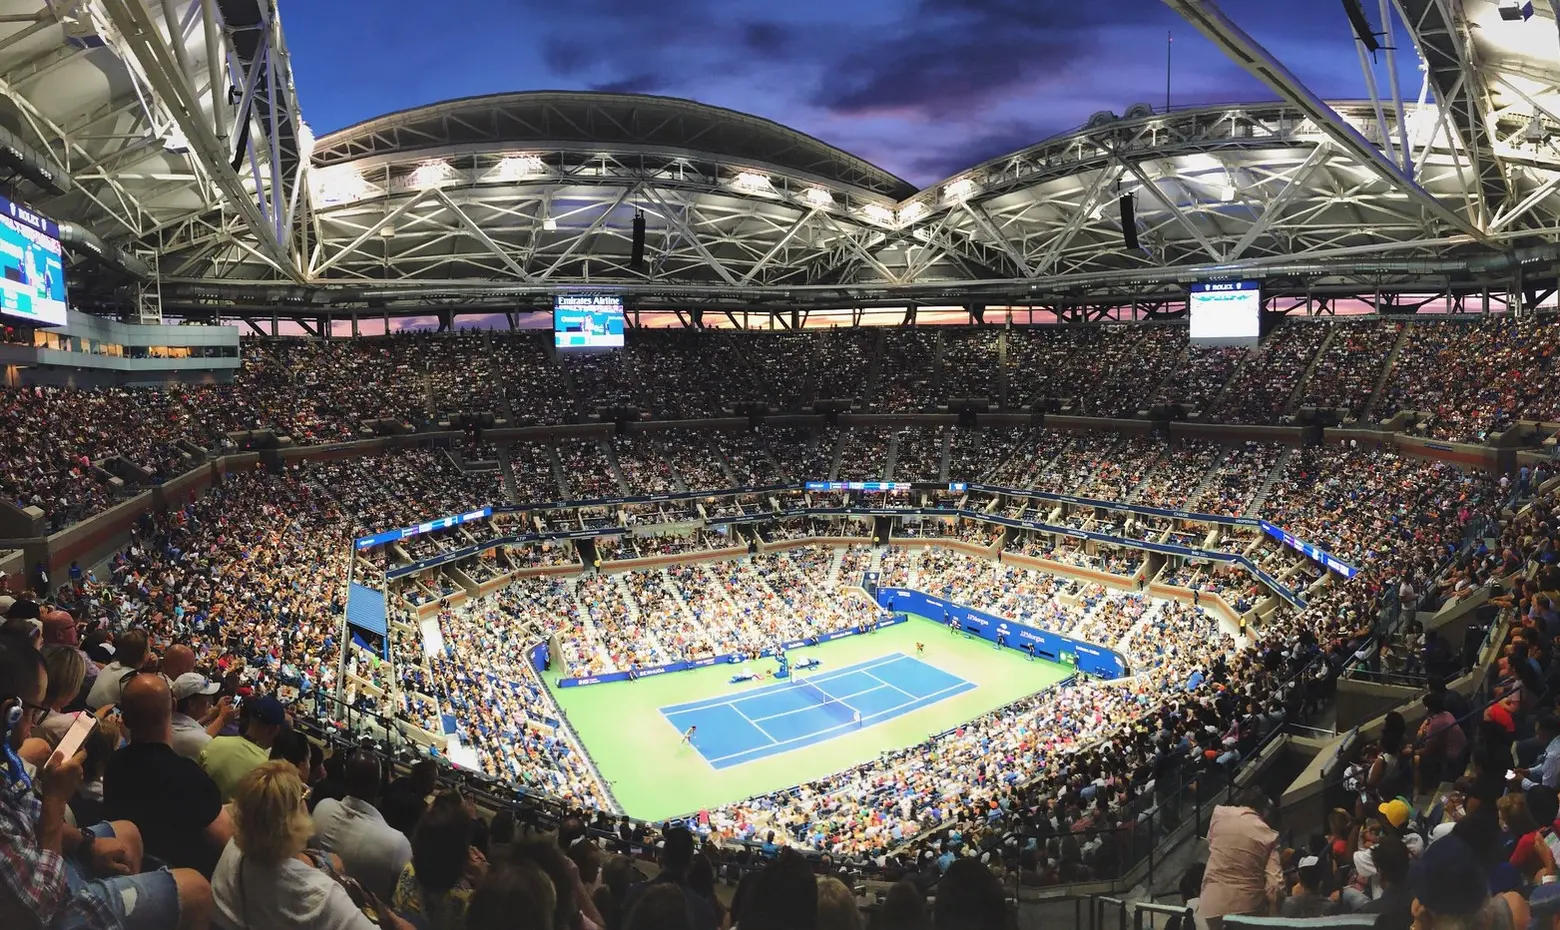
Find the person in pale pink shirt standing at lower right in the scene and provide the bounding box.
[1201,790,1284,930]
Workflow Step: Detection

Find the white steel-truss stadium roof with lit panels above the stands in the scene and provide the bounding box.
[0,0,1560,317]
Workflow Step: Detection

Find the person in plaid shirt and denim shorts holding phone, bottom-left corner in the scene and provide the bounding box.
[0,627,212,930]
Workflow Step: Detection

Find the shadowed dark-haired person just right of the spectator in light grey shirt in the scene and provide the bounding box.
[393,794,487,930]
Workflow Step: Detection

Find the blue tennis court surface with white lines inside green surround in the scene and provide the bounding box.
[661,652,975,769]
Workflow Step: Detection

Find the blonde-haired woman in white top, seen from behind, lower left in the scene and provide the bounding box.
[211,760,412,930]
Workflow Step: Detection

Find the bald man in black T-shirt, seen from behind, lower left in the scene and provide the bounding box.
[103,674,232,879]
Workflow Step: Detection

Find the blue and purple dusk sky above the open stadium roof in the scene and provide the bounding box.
[281,0,1418,186]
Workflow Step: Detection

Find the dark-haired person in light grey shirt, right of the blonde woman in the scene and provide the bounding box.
[314,752,414,900]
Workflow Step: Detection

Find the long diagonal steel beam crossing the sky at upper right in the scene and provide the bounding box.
[1165,0,1485,240]
